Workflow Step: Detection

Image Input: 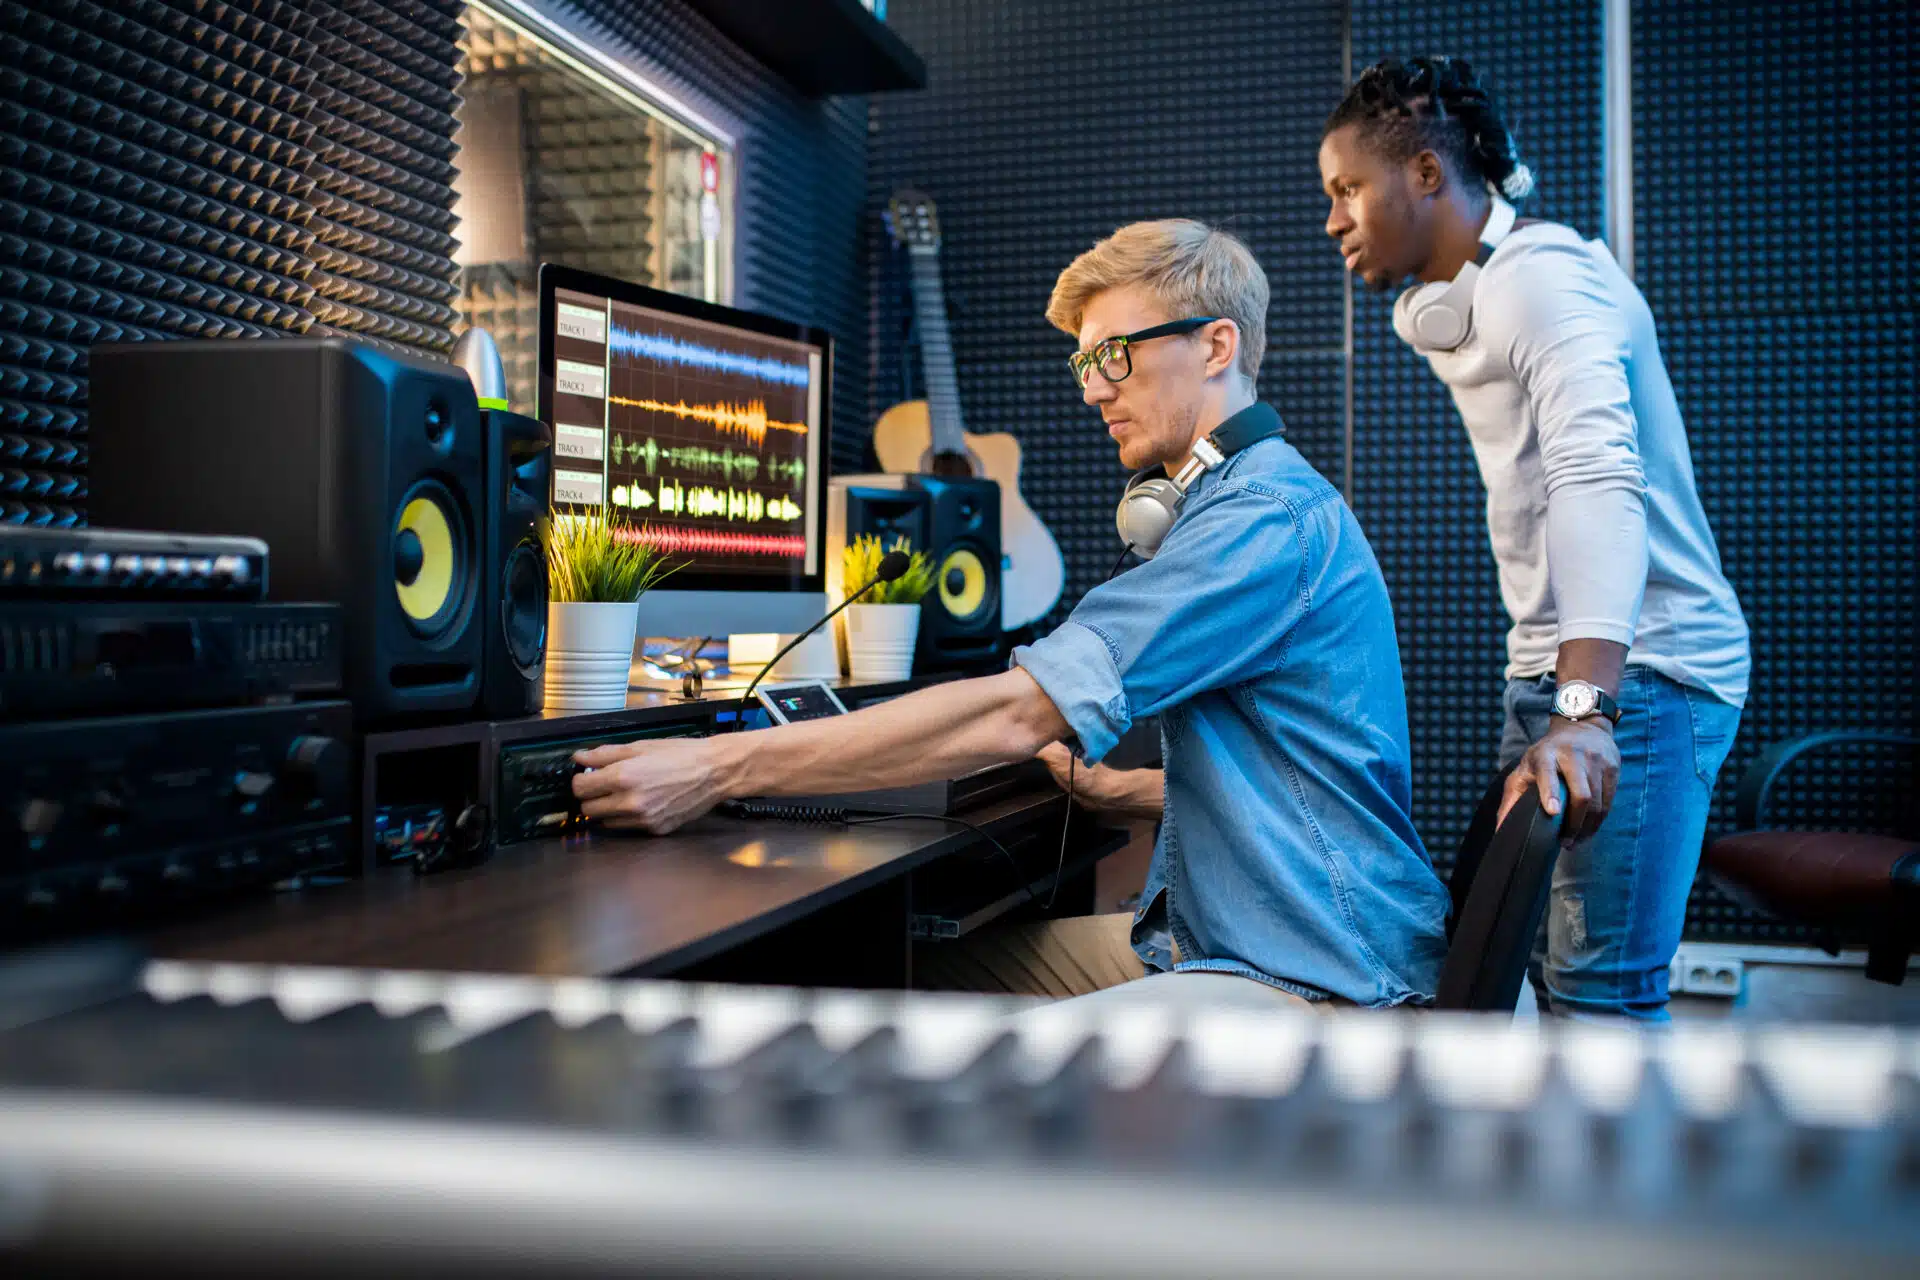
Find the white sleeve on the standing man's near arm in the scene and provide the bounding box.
[1476,242,1647,645]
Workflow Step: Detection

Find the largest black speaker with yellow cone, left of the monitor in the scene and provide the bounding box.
[88,338,486,722]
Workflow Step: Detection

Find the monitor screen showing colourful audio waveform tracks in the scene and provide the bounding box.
[551,288,826,578]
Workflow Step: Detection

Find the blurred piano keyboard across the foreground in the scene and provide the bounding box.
[0,963,1920,1280]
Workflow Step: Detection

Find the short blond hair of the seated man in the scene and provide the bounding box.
[1046,217,1269,382]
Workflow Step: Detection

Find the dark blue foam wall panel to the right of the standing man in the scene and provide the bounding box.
[1634,0,1920,942]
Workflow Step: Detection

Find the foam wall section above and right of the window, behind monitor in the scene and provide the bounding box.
[551,0,872,470]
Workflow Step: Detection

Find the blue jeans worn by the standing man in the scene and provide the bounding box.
[1500,666,1740,1023]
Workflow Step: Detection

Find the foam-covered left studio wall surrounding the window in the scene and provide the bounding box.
[0,0,868,524]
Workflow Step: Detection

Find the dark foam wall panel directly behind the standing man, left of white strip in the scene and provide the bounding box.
[1352,0,1605,882]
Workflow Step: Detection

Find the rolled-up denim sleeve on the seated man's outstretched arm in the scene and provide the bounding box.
[1012,486,1309,764]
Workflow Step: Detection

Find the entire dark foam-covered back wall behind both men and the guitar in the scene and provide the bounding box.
[870,0,1920,942]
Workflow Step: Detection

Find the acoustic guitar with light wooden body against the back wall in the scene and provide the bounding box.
[874,190,1068,631]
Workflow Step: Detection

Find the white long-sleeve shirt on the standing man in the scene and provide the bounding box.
[1402,223,1751,706]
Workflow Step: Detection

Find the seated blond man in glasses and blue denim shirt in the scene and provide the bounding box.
[574,219,1448,1007]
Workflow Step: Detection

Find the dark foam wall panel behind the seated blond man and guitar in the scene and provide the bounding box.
[862,0,1344,622]
